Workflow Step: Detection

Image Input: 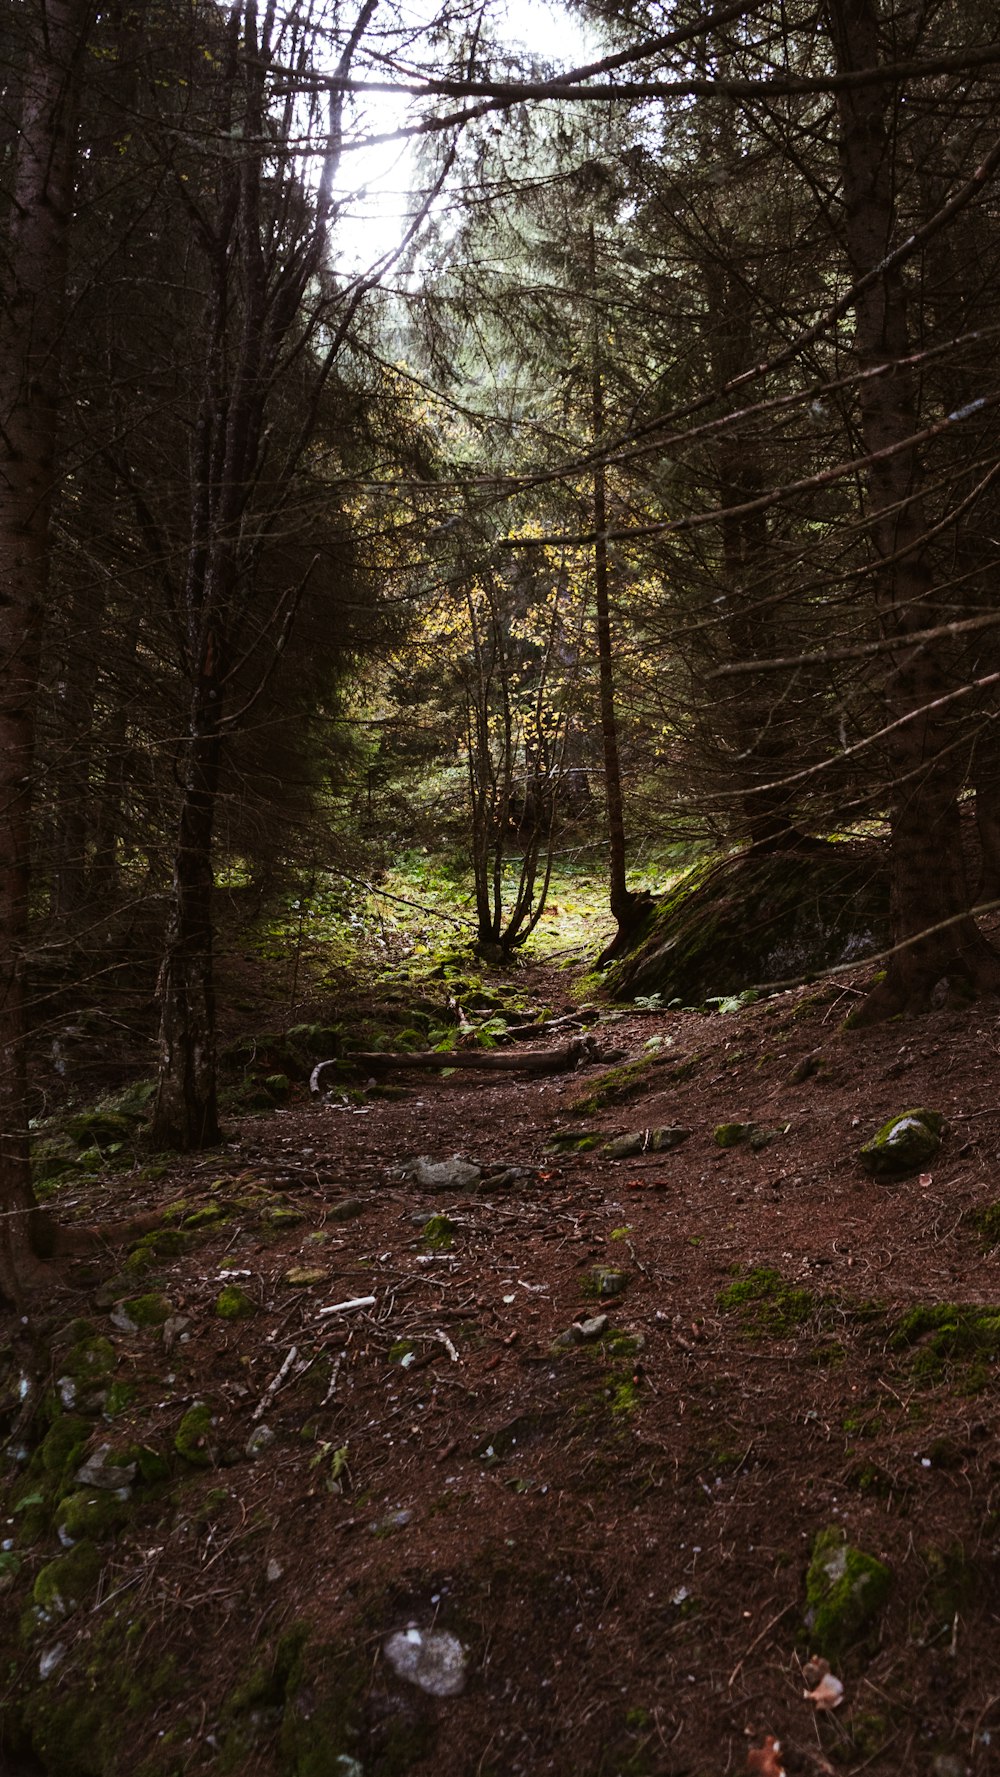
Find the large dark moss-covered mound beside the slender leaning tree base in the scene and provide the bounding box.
[604,844,888,1006]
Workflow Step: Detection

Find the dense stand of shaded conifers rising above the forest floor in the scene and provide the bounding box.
[0,0,1000,1299]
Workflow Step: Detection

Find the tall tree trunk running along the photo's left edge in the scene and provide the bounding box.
[0,0,91,1301]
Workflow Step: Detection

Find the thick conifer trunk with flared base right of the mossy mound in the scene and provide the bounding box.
[829,0,1000,1022]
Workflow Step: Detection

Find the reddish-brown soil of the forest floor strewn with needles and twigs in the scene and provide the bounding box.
[7,988,1000,1777]
